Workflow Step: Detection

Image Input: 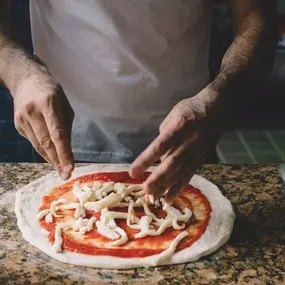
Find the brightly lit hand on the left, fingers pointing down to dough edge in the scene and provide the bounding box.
[13,68,74,180]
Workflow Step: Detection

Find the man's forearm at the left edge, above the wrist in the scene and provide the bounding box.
[0,0,42,95]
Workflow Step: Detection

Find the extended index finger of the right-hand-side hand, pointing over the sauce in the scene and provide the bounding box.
[130,134,177,177]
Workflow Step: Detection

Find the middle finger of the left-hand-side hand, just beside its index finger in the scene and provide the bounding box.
[29,115,61,173]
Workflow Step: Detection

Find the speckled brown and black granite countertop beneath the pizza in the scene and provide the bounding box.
[0,164,285,285]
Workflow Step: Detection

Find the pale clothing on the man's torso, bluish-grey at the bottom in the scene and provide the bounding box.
[31,0,210,162]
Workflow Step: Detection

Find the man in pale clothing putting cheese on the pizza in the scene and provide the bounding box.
[0,0,276,203]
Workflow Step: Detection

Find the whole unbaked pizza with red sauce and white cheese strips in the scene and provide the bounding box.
[16,164,235,269]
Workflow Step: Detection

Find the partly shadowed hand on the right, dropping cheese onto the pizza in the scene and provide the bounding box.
[130,87,224,204]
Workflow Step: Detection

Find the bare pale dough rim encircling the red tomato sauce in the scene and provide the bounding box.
[15,164,235,269]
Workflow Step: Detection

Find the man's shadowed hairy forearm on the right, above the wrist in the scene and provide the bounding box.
[201,1,277,121]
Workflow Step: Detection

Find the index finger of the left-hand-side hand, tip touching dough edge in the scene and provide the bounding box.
[43,94,74,176]
